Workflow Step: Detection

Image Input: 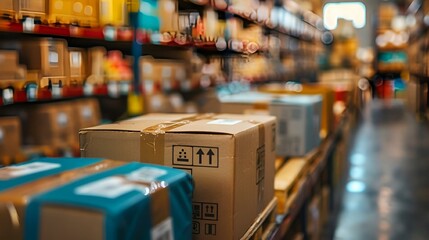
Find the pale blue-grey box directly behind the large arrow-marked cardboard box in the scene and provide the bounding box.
[221,92,322,156]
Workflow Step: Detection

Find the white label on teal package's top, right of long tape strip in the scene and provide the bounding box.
[75,177,138,199]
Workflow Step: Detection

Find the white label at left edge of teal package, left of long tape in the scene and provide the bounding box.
[0,162,61,179]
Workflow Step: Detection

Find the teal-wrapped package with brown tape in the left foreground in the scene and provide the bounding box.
[0,158,193,240]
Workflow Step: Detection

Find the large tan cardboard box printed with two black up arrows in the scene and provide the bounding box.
[79,114,276,239]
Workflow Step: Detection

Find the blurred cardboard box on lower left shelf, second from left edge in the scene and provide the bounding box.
[24,102,78,148]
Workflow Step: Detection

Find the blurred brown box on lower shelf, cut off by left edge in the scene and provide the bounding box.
[0,117,21,157]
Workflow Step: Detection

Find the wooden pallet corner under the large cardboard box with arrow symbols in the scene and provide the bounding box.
[241,198,277,240]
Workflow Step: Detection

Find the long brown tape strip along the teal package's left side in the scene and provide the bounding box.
[0,160,125,240]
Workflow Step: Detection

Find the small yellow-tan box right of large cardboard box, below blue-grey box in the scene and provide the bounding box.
[274,158,307,214]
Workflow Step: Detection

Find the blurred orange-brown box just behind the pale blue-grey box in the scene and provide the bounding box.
[259,84,334,138]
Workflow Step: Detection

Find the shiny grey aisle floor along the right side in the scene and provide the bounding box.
[334,101,429,240]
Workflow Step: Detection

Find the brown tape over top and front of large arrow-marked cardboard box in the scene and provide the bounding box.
[140,113,215,165]
